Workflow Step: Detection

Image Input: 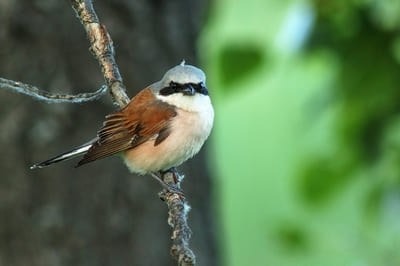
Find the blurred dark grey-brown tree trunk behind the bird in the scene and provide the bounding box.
[0,0,217,266]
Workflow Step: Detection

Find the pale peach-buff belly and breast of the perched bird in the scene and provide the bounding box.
[124,110,213,174]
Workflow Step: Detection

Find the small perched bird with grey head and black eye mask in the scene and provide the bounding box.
[30,61,214,191]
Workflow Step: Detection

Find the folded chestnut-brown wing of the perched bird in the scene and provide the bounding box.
[77,89,176,167]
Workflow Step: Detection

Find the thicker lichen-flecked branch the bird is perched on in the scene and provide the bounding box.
[71,0,196,266]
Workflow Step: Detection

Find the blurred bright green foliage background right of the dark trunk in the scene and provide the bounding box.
[199,0,400,266]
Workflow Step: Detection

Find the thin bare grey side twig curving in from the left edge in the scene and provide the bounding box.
[0,78,107,103]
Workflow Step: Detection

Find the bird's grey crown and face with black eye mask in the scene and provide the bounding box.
[158,62,208,96]
